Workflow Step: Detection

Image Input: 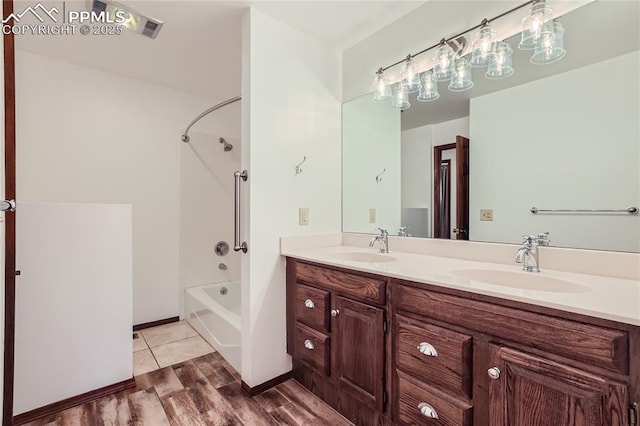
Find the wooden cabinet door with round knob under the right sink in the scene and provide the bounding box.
[488,345,628,426]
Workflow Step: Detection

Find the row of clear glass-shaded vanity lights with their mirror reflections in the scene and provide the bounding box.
[373,0,567,110]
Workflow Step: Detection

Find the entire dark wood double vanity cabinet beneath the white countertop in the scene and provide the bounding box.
[287,259,640,426]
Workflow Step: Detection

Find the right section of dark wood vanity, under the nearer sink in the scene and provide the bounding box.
[391,281,640,426]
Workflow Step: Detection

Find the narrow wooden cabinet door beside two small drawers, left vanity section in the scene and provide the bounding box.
[332,296,384,411]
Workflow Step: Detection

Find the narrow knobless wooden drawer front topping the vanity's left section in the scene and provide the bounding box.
[296,263,386,305]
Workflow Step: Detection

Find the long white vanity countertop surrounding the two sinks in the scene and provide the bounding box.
[281,245,640,326]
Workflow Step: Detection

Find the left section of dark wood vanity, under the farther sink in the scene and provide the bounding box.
[287,259,391,425]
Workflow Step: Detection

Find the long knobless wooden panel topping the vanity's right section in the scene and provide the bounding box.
[397,283,629,374]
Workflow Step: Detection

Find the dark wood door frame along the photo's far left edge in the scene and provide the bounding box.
[2,0,16,426]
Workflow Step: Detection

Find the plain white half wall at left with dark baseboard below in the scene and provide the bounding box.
[14,202,133,414]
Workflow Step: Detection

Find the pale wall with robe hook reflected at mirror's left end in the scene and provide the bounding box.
[342,96,401,234]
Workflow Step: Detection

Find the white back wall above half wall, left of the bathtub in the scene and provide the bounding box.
[16,51,239,324]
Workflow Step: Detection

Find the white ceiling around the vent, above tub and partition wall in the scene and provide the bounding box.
[15,0,424,101]
